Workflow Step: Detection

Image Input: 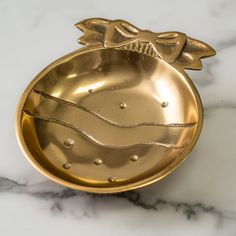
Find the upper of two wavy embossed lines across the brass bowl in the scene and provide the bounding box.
[34,90,196,128]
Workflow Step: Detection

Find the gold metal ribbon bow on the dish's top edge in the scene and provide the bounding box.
[76,18,215,69]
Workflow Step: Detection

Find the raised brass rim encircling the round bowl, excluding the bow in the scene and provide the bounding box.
[15,46,204,194]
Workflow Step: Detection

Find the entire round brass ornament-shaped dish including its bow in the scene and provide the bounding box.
[16,18,215,193]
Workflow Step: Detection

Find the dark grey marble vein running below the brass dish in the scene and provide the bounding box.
[0,177,232,222]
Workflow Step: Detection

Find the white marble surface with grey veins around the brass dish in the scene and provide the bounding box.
[0,0,236,236]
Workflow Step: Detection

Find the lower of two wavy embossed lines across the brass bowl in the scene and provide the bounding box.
[24,110,189,149]
